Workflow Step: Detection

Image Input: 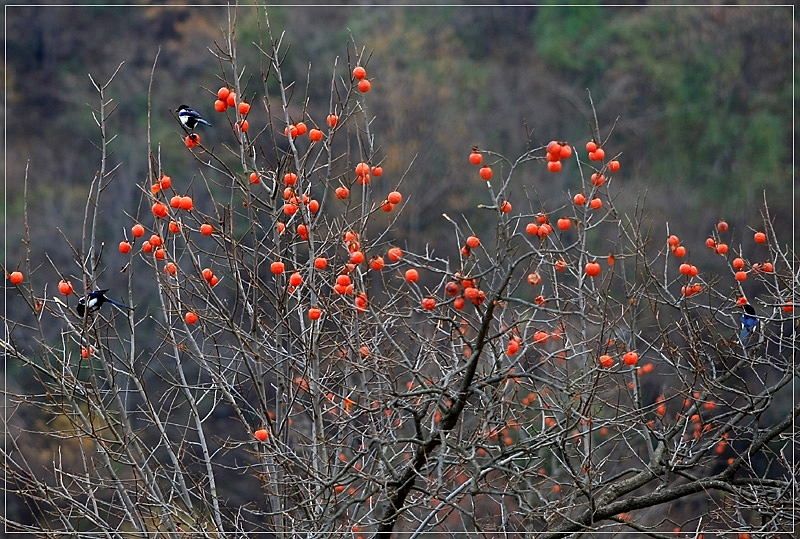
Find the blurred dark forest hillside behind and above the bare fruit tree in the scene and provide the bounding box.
[3,2,797,532]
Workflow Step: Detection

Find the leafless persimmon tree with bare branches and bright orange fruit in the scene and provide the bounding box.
[2,9,800,537]
